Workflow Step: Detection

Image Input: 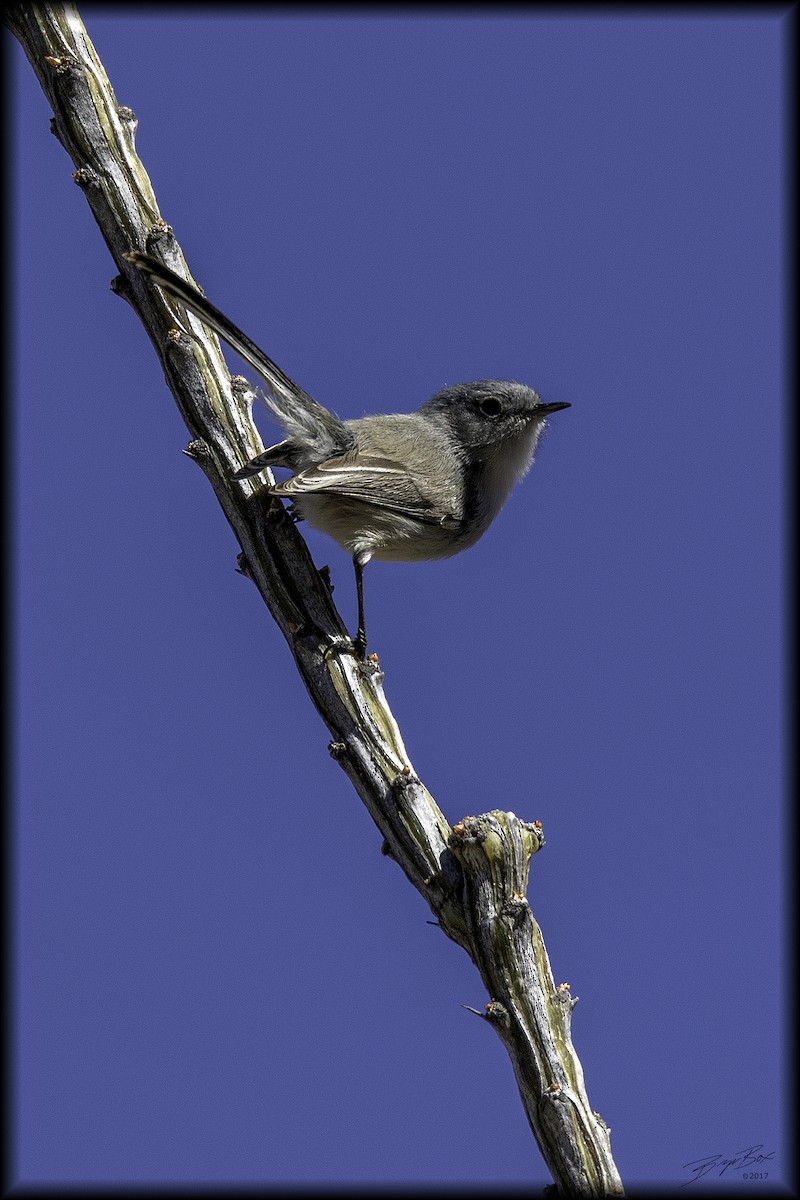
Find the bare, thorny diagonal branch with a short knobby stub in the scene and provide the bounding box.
[6,5,622,1196]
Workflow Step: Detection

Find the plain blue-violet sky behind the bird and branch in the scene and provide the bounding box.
[8,7,790,1190]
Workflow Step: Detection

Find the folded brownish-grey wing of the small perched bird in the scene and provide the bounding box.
[270,450,459,528]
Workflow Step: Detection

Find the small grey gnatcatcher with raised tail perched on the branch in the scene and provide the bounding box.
[125,251,570,658]
